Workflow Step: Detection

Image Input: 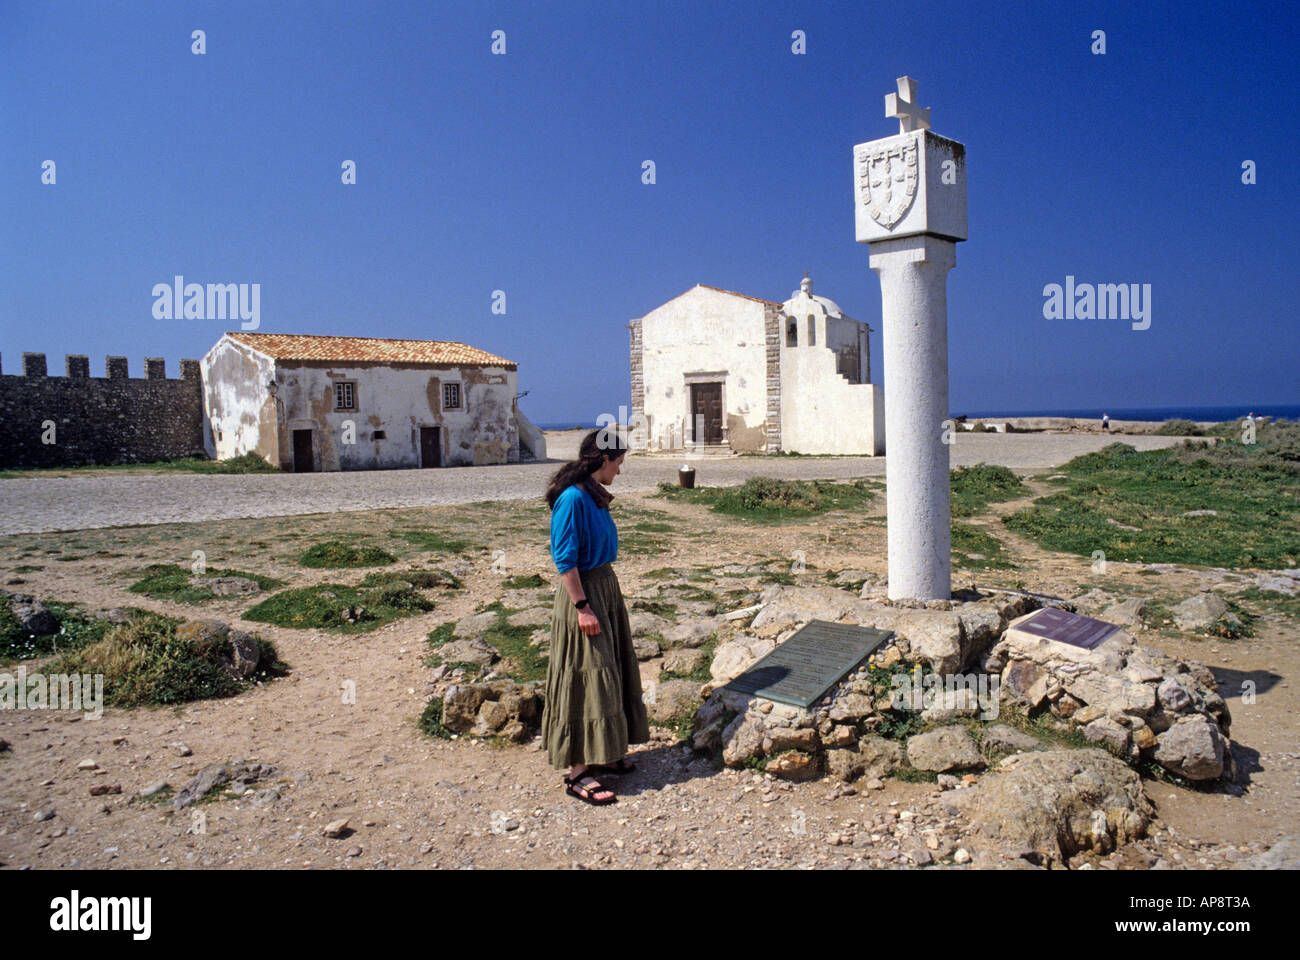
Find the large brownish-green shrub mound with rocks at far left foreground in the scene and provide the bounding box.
[49,613,286,708]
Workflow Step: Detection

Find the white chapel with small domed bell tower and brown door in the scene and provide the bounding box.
[627,276,885,457]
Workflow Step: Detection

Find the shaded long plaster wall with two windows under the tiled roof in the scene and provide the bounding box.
[277,362,519,471]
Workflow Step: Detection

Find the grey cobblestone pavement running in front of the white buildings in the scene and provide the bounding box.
[0,433,1179,535]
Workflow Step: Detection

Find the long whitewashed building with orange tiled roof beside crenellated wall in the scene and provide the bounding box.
[200,332,546,472]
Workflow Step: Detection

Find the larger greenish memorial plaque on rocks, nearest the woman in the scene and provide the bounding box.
[724,620,893,708]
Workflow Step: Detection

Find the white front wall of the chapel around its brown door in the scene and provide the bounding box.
[640,286,767,451]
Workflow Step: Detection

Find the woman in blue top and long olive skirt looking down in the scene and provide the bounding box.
[542,429,650,805]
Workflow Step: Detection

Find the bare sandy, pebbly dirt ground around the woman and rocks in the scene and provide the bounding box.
[0,478,1300,869]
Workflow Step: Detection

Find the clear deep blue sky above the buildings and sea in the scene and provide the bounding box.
[0,0,1300,423]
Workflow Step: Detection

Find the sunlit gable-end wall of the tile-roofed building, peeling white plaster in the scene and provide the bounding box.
[199,337,278,463]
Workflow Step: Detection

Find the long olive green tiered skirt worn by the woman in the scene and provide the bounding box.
[542,563,650,770]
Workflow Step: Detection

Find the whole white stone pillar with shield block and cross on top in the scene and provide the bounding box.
[853,77,966,600]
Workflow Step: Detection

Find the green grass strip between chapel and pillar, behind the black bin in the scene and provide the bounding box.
[655,476,875,523]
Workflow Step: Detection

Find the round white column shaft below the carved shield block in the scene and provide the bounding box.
[871,234,957,600]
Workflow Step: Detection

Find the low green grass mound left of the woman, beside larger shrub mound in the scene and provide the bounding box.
[243,583,436,633]
